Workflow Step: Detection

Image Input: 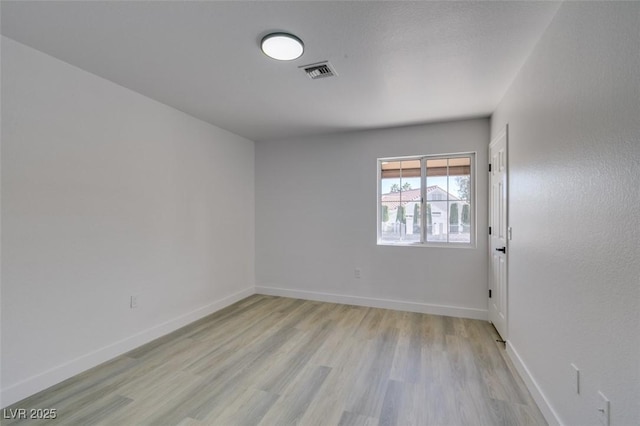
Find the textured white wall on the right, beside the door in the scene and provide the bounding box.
[492,2,640,426]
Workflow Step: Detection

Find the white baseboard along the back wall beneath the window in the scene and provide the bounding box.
[256,286,489,320]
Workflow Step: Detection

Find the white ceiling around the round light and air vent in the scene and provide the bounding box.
[1,1,558,141]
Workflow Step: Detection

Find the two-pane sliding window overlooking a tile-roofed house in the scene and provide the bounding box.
[378,153,475,246]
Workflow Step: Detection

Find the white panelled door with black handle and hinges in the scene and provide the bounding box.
[489,127,509,340]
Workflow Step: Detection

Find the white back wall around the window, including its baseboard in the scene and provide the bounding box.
[256,119,489,318]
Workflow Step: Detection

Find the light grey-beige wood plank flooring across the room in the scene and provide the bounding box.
[2,295,546,426]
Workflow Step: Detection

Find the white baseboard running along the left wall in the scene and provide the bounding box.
[0,287,255,407]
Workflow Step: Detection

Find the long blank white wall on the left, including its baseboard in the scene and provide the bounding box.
[0,37,255,406]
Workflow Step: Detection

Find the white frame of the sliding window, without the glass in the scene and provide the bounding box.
[376,152,477,248]
